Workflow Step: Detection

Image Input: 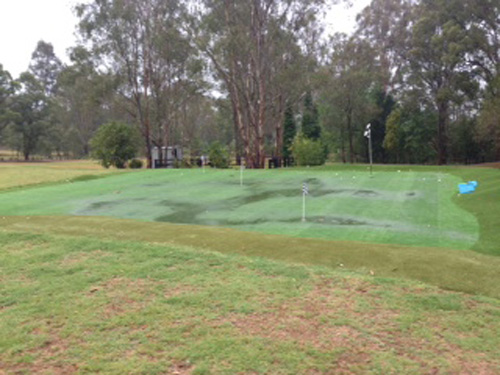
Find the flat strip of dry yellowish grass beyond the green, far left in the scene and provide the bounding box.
[0,161,125,190]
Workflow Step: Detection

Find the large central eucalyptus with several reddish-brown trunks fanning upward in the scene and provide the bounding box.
[192,0,323,168]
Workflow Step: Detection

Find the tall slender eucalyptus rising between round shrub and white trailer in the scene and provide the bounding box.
[77,0,202,167]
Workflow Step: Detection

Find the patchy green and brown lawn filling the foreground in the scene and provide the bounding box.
[0,231,500,375]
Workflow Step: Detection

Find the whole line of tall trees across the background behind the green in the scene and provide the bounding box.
[0,0,500,168]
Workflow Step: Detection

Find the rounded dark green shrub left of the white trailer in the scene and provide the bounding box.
[90,122,138,168]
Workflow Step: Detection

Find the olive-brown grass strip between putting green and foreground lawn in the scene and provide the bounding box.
[0,216,500,298]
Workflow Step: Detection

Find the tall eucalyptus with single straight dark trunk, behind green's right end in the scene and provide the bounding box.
[408,0,477,164]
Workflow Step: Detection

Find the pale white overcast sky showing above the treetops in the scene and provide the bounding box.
[0,0,370,78]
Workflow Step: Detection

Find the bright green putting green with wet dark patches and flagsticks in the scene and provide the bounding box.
[0,169,479,249]
